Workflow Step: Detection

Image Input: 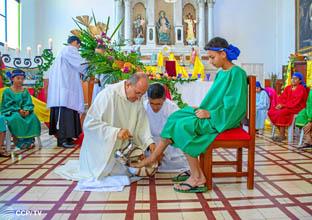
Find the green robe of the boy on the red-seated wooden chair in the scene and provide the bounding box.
[160,66,247,157]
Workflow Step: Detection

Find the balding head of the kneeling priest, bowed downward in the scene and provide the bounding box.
[125,72,149,102]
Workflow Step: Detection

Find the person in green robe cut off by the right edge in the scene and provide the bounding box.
[296,91,312,148]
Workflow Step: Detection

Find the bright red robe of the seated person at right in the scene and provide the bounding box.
[268,85,308,127]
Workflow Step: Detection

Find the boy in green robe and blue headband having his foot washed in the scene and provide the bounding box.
[131,37,247,192]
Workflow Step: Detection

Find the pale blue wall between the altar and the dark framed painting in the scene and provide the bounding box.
[214,0,295,73]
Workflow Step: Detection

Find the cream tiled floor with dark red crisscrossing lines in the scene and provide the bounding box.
[0,125,312,220]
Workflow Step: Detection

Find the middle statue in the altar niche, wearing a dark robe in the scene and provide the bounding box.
[157,11,171,44]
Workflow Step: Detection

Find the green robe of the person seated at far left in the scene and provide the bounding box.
[1,88,40,138]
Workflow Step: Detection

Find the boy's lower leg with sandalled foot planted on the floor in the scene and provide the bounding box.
[174,154,206,190]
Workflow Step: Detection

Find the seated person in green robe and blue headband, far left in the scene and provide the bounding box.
[1,69,41,150]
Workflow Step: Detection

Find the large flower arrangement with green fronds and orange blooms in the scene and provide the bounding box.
[71,14,143,83]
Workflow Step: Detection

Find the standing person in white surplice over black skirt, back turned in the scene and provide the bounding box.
[47,36,87,148]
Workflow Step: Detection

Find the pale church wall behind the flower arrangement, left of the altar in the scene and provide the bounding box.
[33,0,114,54]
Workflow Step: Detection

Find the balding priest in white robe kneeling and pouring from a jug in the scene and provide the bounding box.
[55,73,155,191]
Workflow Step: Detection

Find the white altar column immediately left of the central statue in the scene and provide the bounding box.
[145,0,156,46]
